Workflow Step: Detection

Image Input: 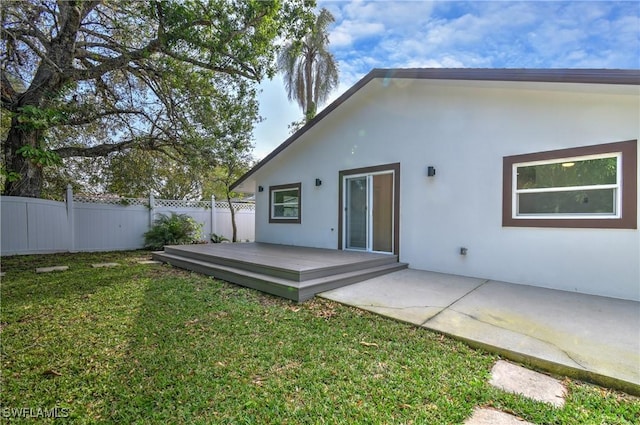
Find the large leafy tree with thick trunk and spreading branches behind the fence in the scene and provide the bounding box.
[0,0,313,197]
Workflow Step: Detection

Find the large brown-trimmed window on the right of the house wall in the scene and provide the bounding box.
[503,140,637,229]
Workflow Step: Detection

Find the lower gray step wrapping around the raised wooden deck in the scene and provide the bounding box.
[152,252,407,302]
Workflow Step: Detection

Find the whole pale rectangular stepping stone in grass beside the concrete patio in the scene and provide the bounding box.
[489,360,567,407]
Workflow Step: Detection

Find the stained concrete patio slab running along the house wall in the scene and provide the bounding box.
[319,269,640,395]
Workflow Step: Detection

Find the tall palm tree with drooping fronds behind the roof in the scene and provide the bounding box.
[278,8,338,125]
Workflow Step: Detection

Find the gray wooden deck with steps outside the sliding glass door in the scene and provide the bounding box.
[153,242,407,302]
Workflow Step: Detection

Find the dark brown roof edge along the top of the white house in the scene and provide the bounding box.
[231,68,640,190]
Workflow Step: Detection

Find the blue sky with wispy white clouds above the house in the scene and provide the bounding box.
[254,0,640,159]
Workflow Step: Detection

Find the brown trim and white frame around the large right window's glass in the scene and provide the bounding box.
[502,140,638,229]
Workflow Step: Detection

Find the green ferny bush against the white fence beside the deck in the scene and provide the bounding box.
[144,213,202,249]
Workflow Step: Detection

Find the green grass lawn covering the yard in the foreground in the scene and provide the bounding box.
[0,251,640,424]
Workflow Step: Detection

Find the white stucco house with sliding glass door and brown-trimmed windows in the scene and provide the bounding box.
[234,69,640,300]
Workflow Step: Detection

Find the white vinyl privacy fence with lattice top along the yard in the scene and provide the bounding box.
[0,184,255,255]
